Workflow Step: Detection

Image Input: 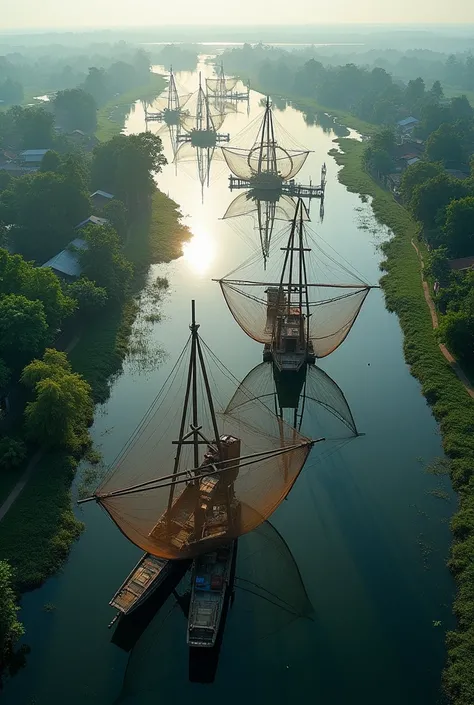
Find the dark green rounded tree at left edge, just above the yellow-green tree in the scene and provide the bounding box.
[0,294,48,366]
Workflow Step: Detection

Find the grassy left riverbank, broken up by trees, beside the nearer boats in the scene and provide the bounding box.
[0,191,189,592]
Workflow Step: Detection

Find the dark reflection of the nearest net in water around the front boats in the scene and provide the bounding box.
[120,522,313,705]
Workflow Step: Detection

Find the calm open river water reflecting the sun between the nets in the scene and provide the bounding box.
[2,59,455,705]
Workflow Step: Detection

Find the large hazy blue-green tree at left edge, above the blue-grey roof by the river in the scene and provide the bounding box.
[0,172,90,263]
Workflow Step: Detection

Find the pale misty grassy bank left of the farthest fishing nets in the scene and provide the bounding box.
[96,73,166,142]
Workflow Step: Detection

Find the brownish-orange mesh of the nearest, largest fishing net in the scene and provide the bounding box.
[96,336,310,559]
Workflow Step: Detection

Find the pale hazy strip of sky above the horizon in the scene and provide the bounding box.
[0,0,474,32]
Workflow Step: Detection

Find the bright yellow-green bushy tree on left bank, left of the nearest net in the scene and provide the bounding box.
[21,350,93,449]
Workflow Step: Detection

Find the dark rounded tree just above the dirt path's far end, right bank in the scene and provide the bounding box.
[410,173,468,228]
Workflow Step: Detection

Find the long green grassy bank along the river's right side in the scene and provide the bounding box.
[333,139,474,705]
